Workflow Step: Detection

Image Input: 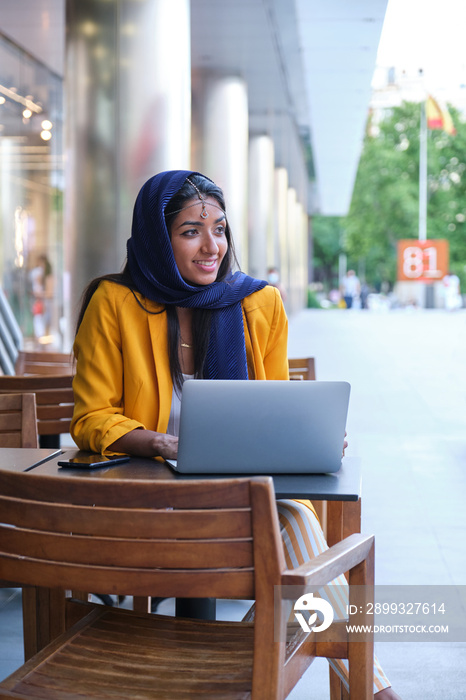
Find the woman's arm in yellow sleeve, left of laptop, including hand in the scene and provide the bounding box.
[71,282,177,457]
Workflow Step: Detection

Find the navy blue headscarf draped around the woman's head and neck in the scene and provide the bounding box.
[127,170,267,379]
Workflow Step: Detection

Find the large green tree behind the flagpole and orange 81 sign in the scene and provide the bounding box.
[342,102,466,288]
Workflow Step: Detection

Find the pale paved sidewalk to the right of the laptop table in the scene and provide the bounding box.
[289,310,466,700]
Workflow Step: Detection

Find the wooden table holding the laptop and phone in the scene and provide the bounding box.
[0,448,361,660]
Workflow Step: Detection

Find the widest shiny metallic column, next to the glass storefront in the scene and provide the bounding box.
[65,0,191,340]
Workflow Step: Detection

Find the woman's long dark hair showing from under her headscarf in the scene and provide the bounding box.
[76,174,238,393]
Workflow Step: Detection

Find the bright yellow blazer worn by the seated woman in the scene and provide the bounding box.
[71,281,288,454]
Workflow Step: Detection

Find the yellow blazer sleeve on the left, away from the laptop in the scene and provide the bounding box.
[71,283,144,454]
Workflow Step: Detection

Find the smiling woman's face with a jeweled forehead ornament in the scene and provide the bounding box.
[170,197,228,285]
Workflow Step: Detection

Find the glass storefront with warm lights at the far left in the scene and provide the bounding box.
[0,33,64,349]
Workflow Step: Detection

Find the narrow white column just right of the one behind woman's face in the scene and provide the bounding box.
[248,135,274,279]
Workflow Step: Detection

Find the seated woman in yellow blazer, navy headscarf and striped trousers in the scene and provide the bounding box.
[71,171,398,700]
